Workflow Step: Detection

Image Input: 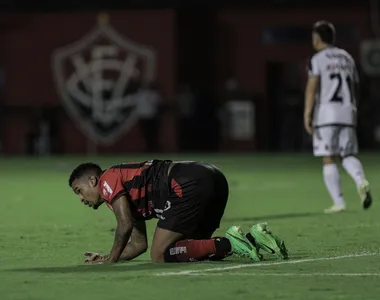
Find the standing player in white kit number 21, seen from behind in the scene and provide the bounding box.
[304,21,372,213]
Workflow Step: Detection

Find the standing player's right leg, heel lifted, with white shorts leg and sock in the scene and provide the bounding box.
[339,127,372,209]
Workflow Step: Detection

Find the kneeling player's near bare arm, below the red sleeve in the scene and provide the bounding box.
[108,195,134,262]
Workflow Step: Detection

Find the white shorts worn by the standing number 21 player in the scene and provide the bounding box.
[313,126,358,157]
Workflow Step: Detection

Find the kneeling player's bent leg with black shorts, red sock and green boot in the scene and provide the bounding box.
[151,163,260,262]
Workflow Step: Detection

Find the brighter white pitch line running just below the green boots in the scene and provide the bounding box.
[155,252,379,277]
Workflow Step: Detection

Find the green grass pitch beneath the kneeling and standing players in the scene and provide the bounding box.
[0,154,380,300]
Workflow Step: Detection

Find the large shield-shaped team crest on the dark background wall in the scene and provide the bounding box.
[53,15,156,144]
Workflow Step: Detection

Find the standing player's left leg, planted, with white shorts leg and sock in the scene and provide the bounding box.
[313,127,345,213]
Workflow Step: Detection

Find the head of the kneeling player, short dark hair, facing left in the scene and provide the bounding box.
[69,163,103,209]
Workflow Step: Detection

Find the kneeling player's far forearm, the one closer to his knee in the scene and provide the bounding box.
[120,220,148,260]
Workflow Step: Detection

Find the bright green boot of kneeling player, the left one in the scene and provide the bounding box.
[226,226,262,261]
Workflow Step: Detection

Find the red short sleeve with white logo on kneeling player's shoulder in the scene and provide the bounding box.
[98,170,126,204]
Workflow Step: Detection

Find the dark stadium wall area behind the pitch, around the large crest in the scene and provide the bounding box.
[0,0,380,155]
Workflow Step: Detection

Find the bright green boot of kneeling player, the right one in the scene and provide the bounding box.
[248,223,289,259]
